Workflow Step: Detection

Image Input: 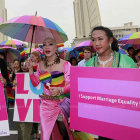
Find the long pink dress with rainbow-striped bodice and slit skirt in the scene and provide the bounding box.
[30,62,74,140]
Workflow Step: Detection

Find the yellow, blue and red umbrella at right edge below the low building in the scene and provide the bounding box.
[118,32,140,45]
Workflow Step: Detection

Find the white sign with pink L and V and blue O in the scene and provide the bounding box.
[14,73,43,122]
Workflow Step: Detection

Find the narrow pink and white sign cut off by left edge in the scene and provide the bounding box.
[0,74,9,136]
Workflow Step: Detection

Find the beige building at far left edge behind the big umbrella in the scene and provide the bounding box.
[0,0,7,42]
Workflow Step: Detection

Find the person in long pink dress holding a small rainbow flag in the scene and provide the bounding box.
[27,38,73,140]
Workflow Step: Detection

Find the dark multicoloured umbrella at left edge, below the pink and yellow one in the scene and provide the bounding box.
[0,47,20,62]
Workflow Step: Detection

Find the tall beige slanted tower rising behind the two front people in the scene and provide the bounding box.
[72,0,101,45]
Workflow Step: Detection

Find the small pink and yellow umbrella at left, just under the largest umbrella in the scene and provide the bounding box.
[0,40,22,48]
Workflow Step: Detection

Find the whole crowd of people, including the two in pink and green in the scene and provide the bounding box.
[0,26,140,140]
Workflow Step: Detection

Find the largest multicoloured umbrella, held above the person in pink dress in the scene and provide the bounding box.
[0,15,68,44]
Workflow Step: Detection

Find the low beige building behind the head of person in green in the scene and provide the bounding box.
[110,22,140,39]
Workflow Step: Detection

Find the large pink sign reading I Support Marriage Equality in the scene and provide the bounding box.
[70,67,140,140]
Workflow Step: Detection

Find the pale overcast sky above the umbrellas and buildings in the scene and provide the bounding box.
[5,0,140,44]
